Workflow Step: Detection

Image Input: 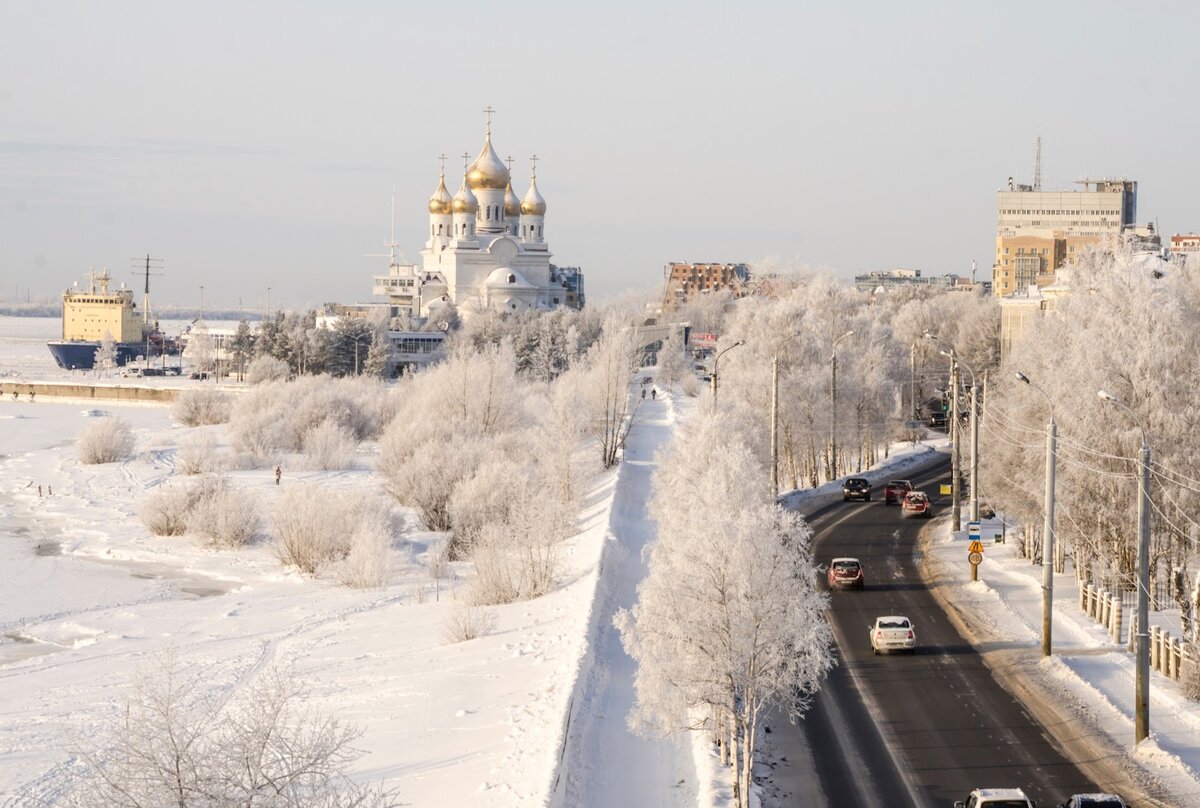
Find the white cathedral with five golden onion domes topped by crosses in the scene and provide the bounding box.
[374,117,583,317]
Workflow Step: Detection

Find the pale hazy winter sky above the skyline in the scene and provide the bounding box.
[0,0,1200,307]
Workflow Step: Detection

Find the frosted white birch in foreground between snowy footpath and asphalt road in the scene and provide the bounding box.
[616,413,833,806]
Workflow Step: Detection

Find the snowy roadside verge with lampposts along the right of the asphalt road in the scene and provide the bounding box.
[925,520,1200,807]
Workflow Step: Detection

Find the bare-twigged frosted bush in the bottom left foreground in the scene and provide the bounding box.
[65,653,401,808]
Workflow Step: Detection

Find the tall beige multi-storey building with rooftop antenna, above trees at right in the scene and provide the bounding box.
[992,178,1138,298]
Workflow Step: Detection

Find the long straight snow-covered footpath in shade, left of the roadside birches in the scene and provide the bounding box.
[551,386,697,808]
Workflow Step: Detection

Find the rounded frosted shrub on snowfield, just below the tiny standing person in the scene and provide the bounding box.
[271,485,395,576]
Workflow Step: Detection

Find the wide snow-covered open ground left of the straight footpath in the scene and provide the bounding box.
[0,318,638,806]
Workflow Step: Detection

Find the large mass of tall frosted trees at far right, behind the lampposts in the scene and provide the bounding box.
[980,244,1200,597]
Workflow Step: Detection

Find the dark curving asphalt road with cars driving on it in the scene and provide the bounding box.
[772,463,1098,808]
